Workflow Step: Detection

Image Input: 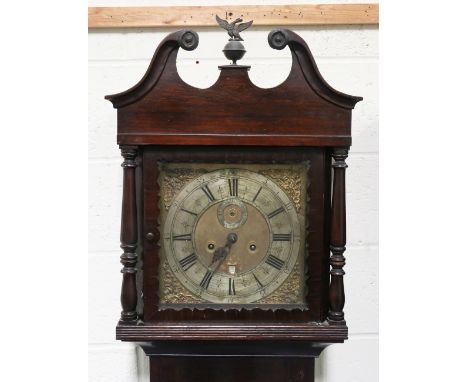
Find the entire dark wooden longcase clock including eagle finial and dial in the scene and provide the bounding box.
[106,18,362,382]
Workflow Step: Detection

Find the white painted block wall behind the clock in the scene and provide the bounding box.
[88,0,379,382]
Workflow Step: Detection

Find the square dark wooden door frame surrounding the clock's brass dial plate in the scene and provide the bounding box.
[141,146,331,322]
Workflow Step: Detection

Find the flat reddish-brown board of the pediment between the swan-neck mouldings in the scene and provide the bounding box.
[118,59,351,144]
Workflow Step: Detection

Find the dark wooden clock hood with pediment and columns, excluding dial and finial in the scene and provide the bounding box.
[106,29,362,344]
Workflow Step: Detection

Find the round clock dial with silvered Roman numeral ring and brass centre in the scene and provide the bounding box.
[163,168,301,304]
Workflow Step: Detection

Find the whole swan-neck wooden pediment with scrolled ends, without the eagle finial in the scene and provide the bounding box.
[106,29,362,146]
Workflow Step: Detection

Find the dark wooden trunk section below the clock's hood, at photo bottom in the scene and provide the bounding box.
[143,341,318,382]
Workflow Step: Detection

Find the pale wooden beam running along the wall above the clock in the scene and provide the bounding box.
[88,4,379,28]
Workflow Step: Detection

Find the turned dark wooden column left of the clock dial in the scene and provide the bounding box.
[120,146,138,324]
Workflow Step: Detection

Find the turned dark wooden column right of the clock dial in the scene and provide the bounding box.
[328,148,348,324]
